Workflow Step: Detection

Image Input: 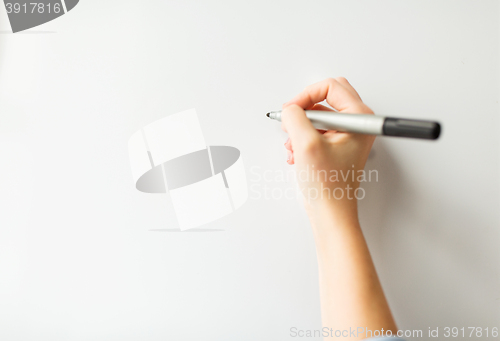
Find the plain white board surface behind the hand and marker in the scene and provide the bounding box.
[0,0,500,341]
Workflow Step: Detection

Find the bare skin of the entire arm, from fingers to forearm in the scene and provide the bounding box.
[282,77,397,340]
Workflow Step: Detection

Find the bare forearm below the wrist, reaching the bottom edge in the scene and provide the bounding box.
[308,202,397,340]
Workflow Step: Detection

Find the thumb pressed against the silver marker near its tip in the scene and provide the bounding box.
[281,104,321,150]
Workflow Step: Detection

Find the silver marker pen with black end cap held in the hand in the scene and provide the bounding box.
[266,110,441,140]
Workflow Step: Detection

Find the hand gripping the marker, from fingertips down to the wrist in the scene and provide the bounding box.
[281,77,375,218]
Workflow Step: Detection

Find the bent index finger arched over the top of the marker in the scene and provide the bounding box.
[284,78,363,111]
